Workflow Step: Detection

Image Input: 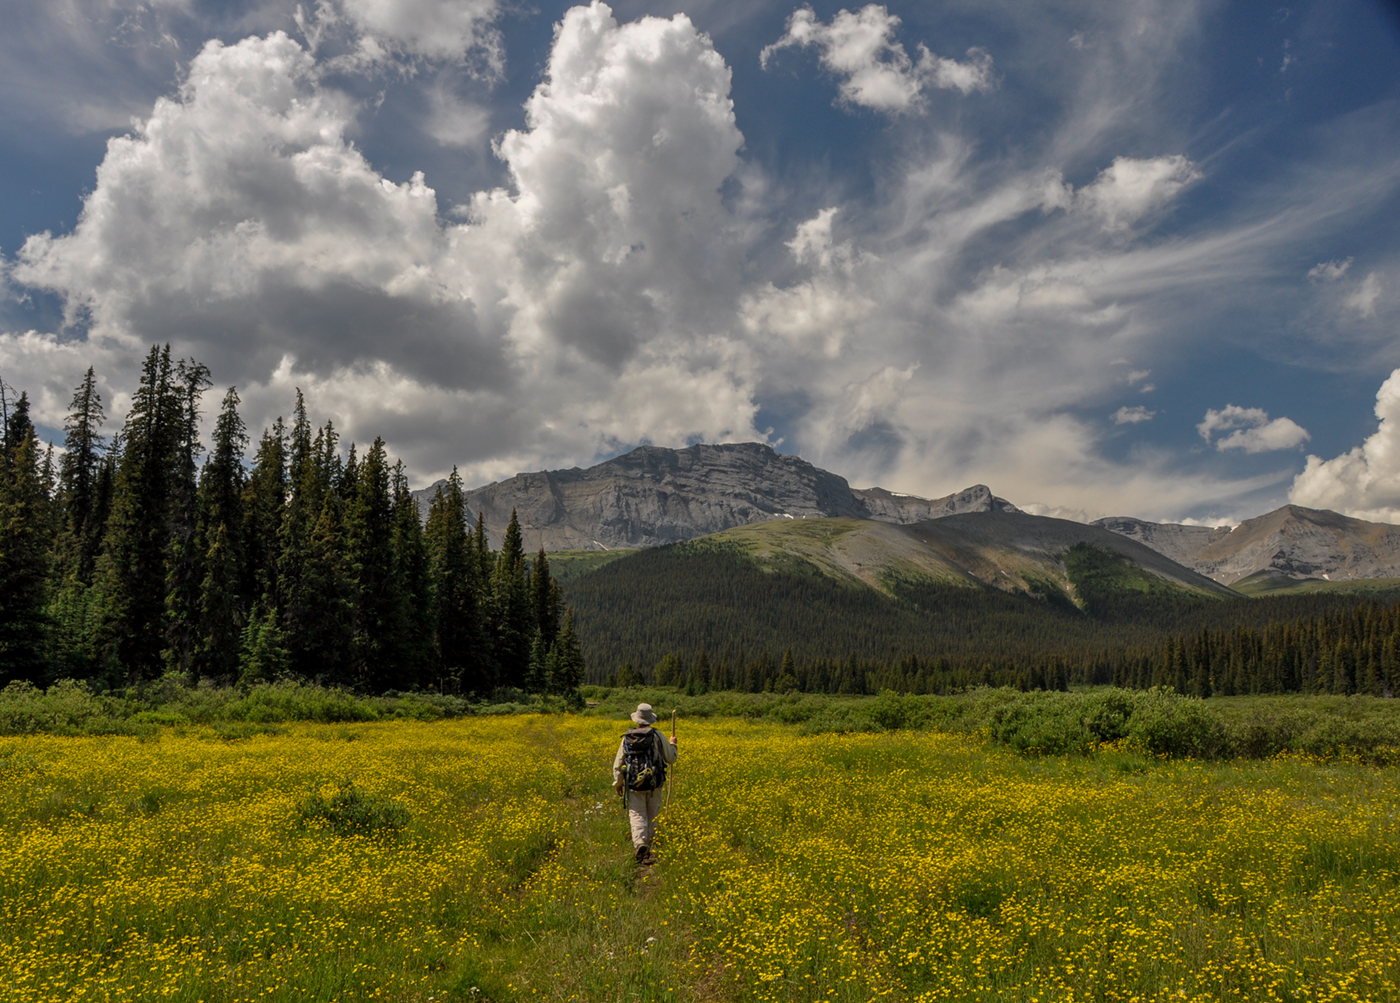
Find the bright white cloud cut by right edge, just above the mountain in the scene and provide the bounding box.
[1288,370,1400,523]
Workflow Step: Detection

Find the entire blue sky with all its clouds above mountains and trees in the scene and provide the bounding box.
[0,0,1400,524]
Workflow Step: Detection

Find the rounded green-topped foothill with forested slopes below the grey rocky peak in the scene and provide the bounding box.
[551,511,1276,671]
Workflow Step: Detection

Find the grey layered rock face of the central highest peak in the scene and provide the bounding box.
[414,443,1016,551]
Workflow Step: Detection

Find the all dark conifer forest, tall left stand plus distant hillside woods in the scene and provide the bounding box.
[0,346,1400,699]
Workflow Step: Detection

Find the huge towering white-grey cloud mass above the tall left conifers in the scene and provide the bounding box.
[0,3,762,478]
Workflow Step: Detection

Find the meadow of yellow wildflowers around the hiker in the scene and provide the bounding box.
[0,716,1400,1003]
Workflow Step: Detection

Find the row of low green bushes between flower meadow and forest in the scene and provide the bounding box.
[0,678,1400,763]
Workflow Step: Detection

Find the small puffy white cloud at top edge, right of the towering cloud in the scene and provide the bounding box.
[759,4,995,112]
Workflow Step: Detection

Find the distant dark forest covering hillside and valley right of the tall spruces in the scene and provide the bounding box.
[566,541,1400,696]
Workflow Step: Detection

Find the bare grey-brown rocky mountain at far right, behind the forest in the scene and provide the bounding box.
[1095,506,1400,582]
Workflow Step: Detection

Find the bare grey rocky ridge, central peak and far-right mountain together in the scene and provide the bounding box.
[414,443,1400,591]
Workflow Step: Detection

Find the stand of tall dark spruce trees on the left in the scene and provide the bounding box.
[0,346,584,695]
